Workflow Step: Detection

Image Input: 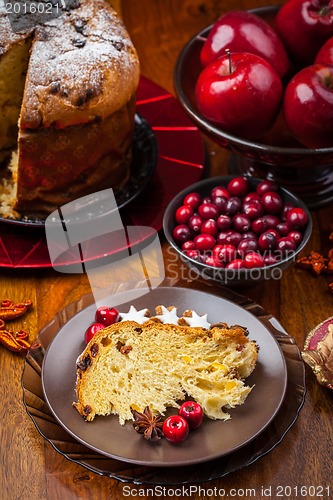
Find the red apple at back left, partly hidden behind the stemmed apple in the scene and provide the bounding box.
[200,11,289,78]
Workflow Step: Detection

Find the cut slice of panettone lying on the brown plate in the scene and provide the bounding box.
[74,320,257,424]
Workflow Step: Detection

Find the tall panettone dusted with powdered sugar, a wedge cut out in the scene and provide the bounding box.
[0,0,139,214]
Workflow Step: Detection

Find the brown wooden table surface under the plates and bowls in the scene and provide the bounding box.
[0,0,333,500]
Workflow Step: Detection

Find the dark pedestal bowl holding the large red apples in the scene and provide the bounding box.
[174,6,333,208]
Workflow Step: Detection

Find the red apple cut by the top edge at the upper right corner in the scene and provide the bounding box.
[276,0,333,65]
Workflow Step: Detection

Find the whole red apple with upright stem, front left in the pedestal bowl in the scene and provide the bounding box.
[195,52,282,139]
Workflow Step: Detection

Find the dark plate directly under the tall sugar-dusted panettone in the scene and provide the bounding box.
[0,113,158,228]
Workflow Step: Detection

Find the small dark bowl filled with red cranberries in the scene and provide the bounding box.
[163,176,312,287]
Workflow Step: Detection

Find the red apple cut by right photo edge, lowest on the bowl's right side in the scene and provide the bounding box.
[283,64,333,148]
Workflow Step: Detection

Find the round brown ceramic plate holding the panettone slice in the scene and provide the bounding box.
[42,287,287,467]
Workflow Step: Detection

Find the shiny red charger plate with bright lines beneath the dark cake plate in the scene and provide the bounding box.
[0,77,205,268]
